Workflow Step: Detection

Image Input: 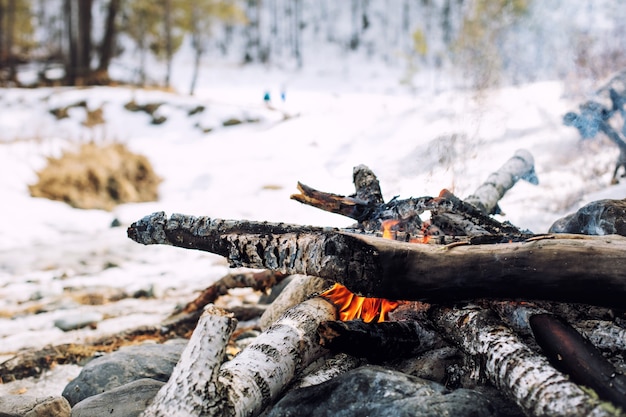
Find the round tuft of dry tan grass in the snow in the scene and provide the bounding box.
[28,143,161,210]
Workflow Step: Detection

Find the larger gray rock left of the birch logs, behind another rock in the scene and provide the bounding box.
[63,339,187,406]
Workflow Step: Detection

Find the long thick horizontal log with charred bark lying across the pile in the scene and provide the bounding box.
[128,212,626,308]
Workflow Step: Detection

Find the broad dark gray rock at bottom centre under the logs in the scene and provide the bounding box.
[266,366,497,417]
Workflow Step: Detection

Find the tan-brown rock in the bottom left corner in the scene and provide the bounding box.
[0,395,71,417]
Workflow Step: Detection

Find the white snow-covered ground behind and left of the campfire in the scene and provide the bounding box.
[0,59,626,395]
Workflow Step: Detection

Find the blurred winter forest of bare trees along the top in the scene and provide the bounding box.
[0,0,626,92]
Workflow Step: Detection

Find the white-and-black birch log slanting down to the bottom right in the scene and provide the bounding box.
[432,307,624,417]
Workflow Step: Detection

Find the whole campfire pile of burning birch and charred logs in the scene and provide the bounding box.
[128,150,626,416]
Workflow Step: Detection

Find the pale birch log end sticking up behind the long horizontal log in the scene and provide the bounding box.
[465,149,539,214]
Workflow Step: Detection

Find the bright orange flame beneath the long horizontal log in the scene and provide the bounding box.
[320,284,400,323]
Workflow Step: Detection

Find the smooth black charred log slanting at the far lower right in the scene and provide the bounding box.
[529,314,626,410]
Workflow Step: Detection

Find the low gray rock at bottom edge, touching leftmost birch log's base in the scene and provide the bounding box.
[72,378,165,417]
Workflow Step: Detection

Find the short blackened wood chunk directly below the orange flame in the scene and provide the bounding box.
[317,320,427,363]
